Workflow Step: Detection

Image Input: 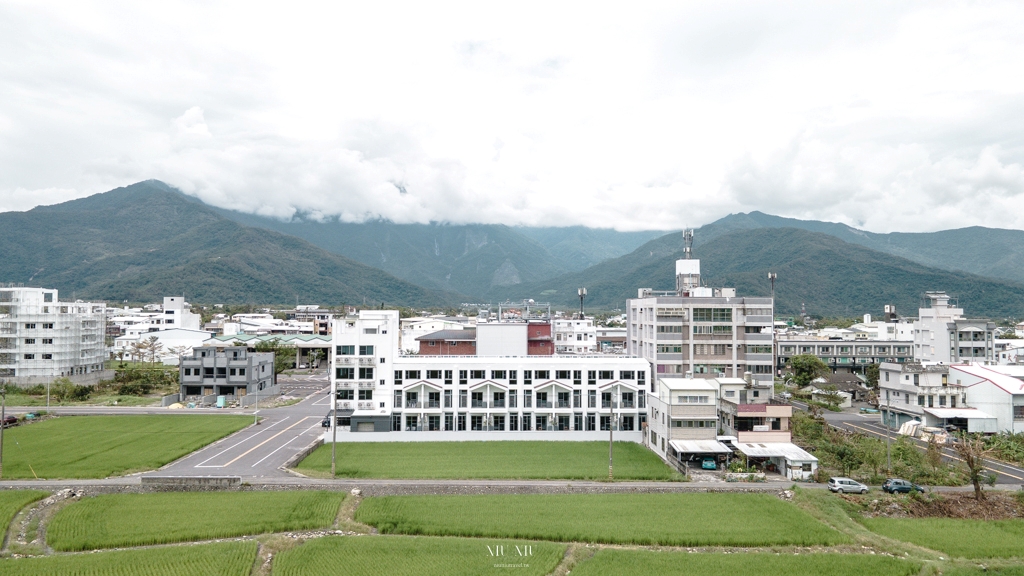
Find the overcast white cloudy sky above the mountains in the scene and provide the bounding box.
[0,0,1024,232]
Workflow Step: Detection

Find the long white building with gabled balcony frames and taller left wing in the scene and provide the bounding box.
[325,311,650,442]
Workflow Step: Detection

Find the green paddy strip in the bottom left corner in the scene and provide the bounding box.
[0,541,256,576]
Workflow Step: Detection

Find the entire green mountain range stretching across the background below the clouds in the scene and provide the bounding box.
[0,180,1024,318]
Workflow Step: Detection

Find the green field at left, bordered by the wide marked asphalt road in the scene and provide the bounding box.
[3,414,252,479]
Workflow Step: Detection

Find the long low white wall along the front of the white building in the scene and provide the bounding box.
[324,428,643,444]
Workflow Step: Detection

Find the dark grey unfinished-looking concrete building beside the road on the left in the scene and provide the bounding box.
[178,346,281,405]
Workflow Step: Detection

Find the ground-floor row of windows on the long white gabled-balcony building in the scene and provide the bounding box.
[391,412,646,431]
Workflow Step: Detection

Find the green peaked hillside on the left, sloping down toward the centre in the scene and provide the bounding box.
[0,180,460,305]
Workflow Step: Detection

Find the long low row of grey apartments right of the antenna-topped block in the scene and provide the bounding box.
[775,335,913,374]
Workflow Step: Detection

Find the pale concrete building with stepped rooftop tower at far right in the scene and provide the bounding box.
[913,292,995,364]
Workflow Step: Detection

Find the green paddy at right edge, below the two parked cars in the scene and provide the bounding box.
[861,518,1024,558]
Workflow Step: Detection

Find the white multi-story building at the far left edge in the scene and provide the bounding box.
[0,287,106,384]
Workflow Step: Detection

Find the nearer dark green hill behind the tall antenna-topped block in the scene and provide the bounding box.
[506,224,1024,318]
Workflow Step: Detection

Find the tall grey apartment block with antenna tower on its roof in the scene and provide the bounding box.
[626,259,773,387]
